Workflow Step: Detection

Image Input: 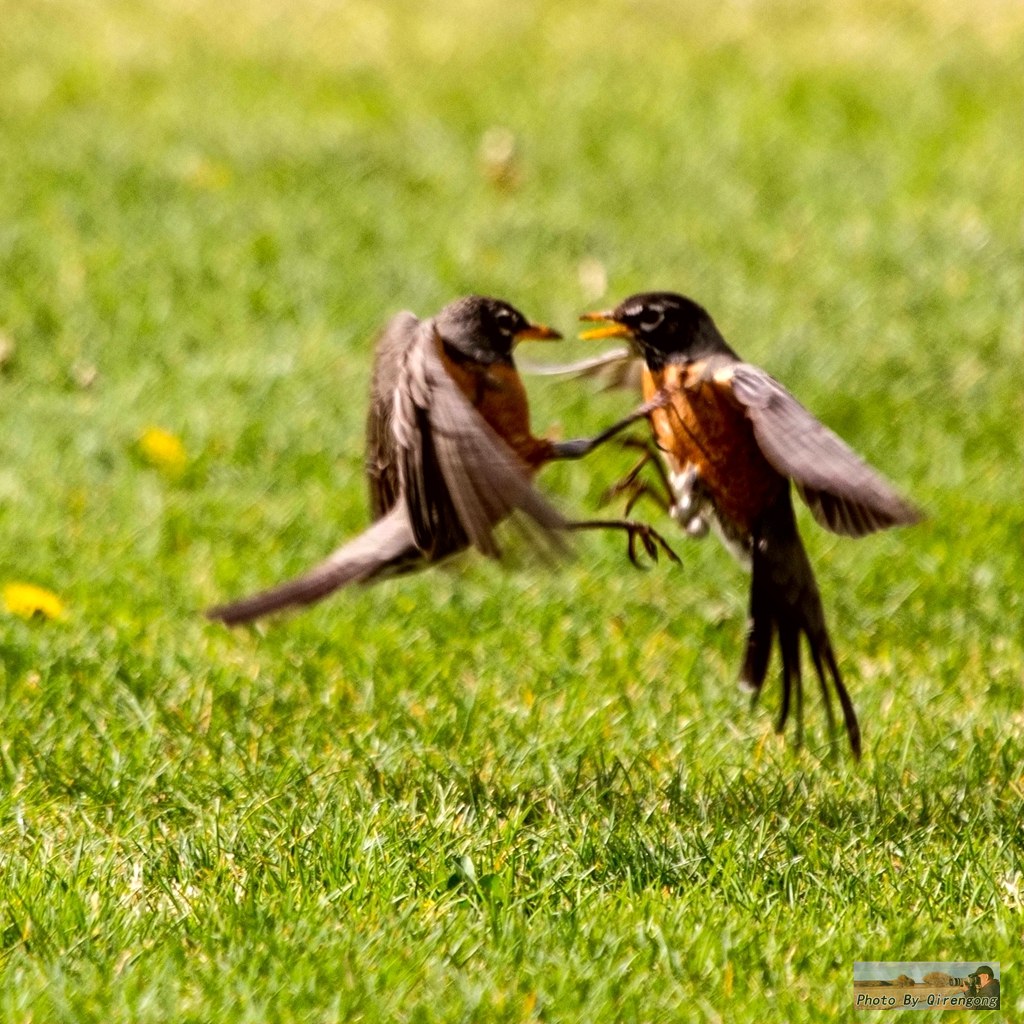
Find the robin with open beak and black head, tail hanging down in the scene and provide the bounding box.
[581,292,922,758]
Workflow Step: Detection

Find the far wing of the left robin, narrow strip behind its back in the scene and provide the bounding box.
[366,312,420,519]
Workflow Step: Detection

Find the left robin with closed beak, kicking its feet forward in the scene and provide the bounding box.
[207,296,676,625]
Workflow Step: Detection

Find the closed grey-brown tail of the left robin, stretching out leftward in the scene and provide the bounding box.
[206,505,423,626]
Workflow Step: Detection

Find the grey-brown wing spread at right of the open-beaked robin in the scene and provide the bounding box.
[714,362,922,537]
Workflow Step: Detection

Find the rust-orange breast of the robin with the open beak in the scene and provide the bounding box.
[643,364,783,530]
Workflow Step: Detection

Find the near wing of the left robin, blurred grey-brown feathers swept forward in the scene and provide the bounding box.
[394,321,566,557]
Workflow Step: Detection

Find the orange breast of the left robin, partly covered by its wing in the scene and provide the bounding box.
[441,350,551,473]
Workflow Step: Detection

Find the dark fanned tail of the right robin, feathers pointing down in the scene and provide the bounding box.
[740,488,860,760]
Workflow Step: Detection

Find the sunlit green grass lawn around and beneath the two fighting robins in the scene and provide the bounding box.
[0,0,1024,1022]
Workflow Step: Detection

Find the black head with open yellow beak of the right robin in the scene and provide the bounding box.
[580,292,732,369]
